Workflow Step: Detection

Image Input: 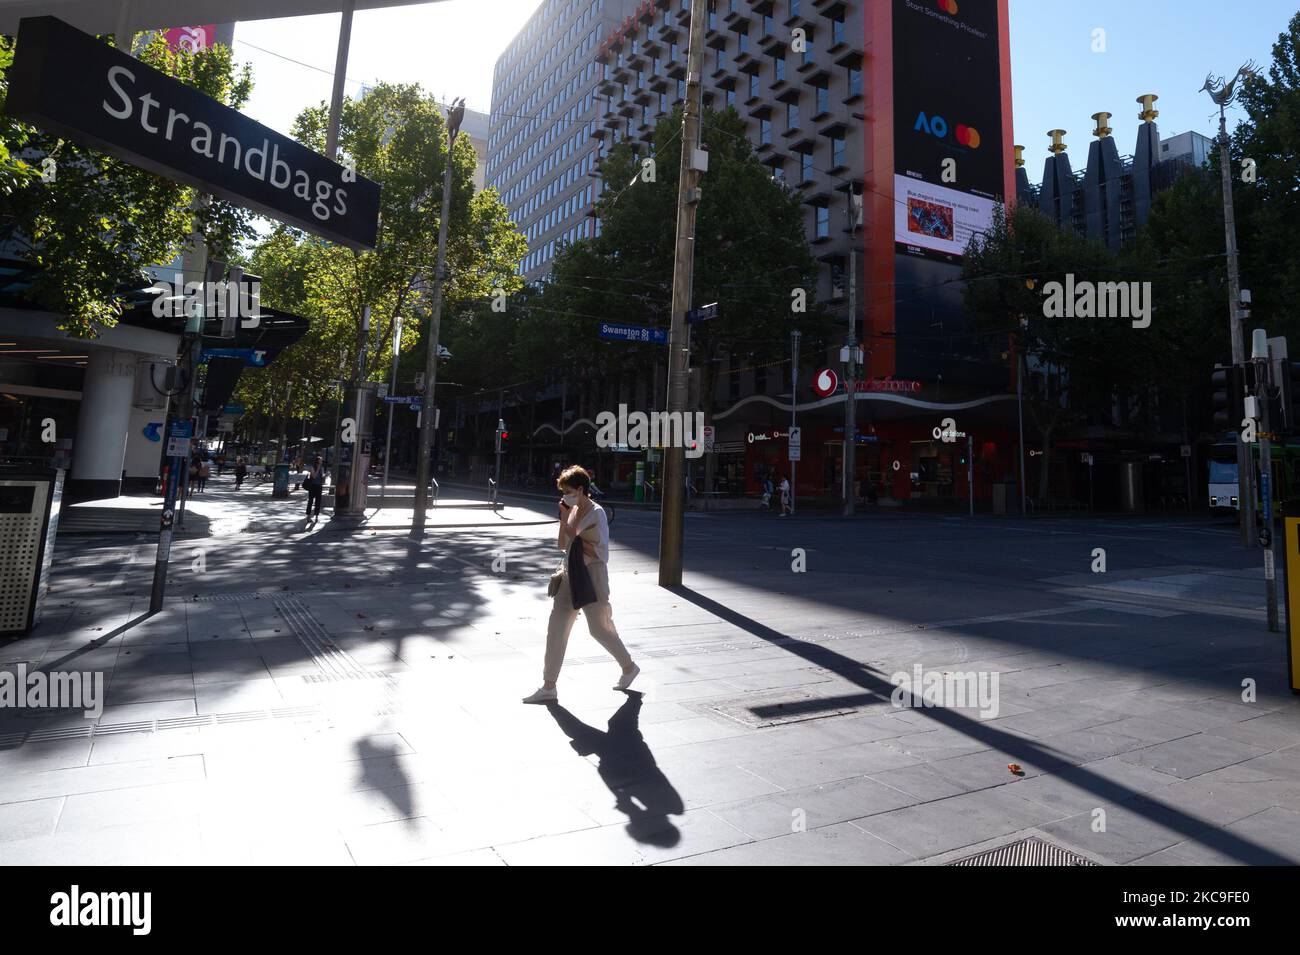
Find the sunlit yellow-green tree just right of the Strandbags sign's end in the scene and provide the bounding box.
[239,83,527,426]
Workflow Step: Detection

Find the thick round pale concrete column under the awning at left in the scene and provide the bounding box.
[65,348,137,502]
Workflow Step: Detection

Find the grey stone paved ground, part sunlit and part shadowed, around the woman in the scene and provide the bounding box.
[0,478,1300,865]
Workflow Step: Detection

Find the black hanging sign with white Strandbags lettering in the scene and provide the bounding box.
[5,17,380,248]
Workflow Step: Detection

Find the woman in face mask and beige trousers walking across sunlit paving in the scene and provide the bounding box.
[524,465,641,703]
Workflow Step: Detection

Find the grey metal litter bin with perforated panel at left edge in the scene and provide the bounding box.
[0,468,64,634]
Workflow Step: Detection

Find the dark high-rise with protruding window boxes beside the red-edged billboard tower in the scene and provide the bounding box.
[592,0,865,304]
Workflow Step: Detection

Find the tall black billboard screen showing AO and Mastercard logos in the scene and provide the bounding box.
[892,0,1006,262]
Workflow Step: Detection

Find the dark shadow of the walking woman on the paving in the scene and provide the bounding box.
[547,690,686,847]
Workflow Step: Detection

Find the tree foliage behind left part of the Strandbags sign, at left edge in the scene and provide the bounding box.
[0,34,252,337]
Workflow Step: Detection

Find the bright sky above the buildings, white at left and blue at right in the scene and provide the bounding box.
[228,0,1297,167]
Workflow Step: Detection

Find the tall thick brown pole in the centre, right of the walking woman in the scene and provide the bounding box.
[659,0,709,587]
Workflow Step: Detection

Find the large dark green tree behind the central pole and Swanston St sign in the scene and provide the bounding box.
[536,108,832,428]
